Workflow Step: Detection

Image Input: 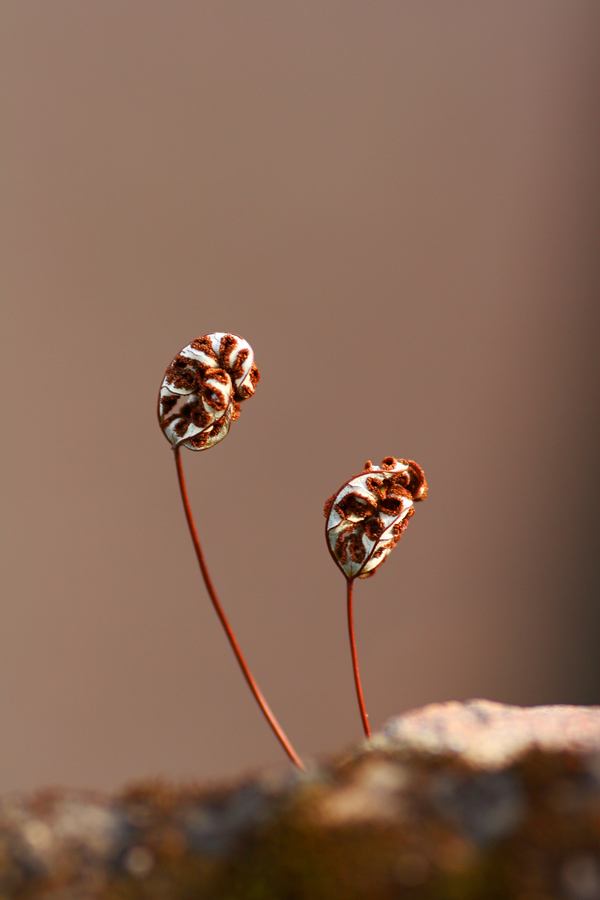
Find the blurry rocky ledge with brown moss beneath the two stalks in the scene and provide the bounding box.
[0,700,600,900]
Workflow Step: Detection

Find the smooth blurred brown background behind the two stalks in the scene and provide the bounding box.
[0,0,600,790]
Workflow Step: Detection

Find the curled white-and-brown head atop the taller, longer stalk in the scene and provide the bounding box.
[158,331,260,450]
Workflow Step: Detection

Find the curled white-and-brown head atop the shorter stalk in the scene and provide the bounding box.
[325,456,427,578]
